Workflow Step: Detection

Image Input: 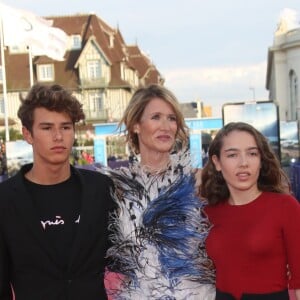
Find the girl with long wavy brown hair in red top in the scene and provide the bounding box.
[200,122,300,300]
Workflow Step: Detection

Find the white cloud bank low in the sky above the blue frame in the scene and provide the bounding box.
[163,61,268,115]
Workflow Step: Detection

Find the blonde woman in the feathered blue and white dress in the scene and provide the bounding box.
[108,85,215,300]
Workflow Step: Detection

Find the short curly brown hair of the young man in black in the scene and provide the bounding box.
[18,84,85,132]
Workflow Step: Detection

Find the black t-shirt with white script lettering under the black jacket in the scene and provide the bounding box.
[25,174,81,267]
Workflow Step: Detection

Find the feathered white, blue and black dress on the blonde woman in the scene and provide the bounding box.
[108,151,215,300]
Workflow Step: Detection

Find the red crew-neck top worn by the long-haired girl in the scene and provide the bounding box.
[206,192,300,299]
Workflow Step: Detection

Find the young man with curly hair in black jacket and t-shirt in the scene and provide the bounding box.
[0,85,113,300]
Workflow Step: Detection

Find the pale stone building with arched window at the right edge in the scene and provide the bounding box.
[266,11,300,121]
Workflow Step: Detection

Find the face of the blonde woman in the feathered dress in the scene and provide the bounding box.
[134,98,178,159]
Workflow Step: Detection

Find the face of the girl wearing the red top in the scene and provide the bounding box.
[212,130,261,195]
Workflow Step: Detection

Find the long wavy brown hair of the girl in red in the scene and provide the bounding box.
[199,122,289,204]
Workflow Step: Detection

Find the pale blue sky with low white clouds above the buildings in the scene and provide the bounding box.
[1,0,300,117]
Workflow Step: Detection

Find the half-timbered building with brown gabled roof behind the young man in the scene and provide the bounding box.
[0,14,164,128]
